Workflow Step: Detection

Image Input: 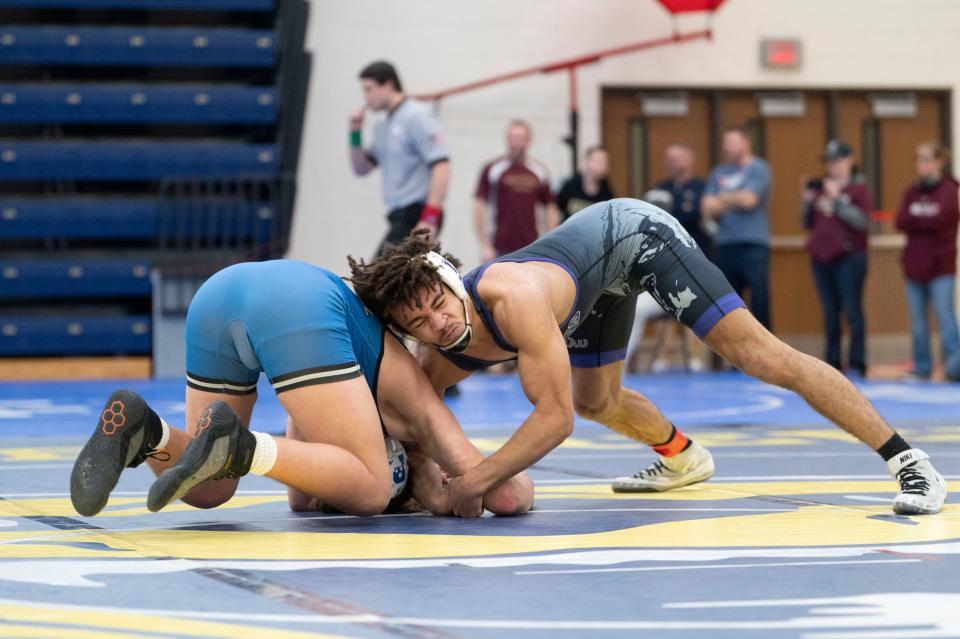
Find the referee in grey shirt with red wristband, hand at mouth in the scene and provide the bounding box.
[350,61,450,255]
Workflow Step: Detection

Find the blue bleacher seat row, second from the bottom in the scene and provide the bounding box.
[0,259,150,299]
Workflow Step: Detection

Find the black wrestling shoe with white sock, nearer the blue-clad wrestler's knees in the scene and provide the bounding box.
[147,401,257,512]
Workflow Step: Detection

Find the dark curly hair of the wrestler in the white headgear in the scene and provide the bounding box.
[347,229,460,321]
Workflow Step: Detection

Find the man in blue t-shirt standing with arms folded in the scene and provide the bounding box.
[700,128,770,329]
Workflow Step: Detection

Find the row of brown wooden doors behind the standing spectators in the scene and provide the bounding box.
[602,88,946,348]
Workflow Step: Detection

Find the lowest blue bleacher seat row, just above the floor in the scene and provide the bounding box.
[0,315,151,356]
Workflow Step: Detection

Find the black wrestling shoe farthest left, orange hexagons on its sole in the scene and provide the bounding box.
[70,390,162,517]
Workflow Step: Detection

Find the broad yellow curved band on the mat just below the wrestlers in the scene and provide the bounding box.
[0,490,960,560]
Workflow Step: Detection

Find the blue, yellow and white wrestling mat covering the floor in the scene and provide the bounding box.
[0,373,960,639]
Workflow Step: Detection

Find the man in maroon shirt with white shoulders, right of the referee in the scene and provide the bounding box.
[473,120,560,261]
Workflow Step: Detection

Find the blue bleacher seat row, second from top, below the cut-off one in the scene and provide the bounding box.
[0,26,277,67]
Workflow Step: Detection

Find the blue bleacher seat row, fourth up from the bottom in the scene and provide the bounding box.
[0,140,279,182]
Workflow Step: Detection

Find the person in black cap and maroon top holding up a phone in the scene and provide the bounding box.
[801,140,873,377]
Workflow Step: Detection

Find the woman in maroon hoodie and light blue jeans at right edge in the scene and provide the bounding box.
[897,142,960,381]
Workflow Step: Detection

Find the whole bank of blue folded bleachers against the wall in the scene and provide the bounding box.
[0,0,310,356]
